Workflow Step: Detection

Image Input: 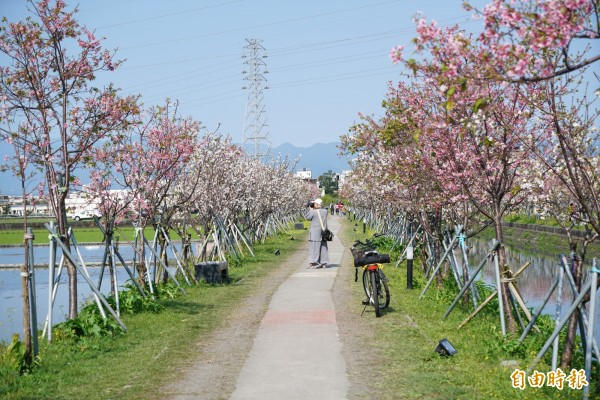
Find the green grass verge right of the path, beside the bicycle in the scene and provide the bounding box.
[345,222,600,399]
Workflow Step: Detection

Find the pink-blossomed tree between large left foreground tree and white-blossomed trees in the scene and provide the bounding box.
[92,99,200,286]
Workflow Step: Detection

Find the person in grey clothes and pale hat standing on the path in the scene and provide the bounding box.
[306,199,329,268]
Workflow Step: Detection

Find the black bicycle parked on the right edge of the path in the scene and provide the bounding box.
[350,240,390,317]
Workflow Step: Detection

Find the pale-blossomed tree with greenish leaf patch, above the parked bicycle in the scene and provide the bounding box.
[342,88,454,294]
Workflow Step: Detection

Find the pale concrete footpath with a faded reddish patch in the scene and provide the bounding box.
[231,215,349,400]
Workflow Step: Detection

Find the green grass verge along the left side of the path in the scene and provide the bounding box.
[0,225,306,400]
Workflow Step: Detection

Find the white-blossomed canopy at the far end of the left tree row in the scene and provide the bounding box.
[178,135,314,258]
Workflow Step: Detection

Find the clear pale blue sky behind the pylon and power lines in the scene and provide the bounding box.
[0,0,480,147]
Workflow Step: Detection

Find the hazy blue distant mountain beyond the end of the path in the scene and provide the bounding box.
[271,142,350,178]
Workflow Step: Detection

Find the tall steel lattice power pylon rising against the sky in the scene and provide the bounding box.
[242,39,271,161]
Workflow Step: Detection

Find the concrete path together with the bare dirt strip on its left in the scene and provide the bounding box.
[162,216,356,400]
